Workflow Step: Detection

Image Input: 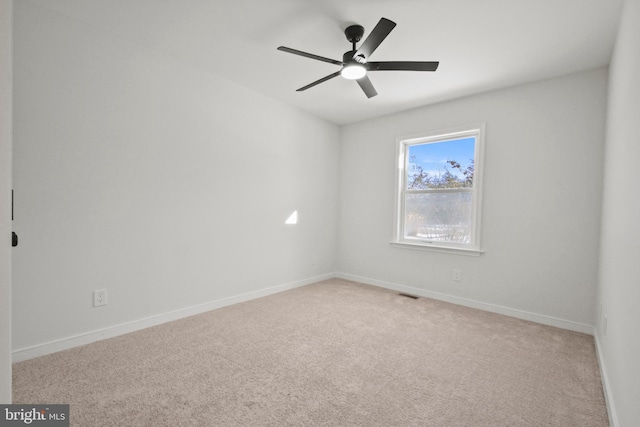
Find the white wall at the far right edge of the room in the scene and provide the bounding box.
[596,0,640,427]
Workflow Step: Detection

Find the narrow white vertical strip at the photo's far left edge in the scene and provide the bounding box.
[0,0,13,403]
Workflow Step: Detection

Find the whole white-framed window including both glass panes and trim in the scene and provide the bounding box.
[393,124,484,254]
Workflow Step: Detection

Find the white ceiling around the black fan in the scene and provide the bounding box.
[30,0,622,124]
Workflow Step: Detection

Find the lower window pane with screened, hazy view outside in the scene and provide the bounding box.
[404,191,473,244]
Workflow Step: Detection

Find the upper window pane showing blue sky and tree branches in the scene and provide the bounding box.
[406,136,476,190]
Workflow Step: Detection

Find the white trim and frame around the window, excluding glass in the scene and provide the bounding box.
[391,123,485,256]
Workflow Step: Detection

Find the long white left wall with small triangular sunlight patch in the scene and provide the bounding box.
[13,2,339,351]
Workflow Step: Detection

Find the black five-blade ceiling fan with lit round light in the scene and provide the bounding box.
[278,18,439,98]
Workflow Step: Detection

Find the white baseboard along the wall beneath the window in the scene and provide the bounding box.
[335,273,593,335]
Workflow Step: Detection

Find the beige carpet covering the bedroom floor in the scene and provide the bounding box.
[13,279,608,427]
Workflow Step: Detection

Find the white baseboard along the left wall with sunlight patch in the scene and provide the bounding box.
[12,273,335,363]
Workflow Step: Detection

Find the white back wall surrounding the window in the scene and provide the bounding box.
[338,69,607,331]
